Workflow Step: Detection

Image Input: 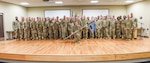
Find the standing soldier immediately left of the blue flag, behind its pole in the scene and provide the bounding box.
[81,16,88,39]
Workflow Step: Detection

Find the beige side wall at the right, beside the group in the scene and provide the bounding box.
[127,0,150,36]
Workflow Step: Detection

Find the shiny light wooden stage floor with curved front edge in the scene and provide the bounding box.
[0,38,150,61]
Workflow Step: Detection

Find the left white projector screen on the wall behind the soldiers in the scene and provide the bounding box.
[44,10,71,18]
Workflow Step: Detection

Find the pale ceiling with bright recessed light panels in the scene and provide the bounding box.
[0,0,142,7]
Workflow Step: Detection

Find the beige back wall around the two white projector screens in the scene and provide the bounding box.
[27,6,127,17]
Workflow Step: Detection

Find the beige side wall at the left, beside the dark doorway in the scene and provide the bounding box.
[0,1,27,39]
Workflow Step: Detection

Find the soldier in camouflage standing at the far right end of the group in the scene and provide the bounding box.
[130,13,138,39]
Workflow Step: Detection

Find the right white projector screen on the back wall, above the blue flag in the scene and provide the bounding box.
[82,9,109,17]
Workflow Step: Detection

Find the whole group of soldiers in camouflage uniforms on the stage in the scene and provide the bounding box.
[13,13,137,42]
